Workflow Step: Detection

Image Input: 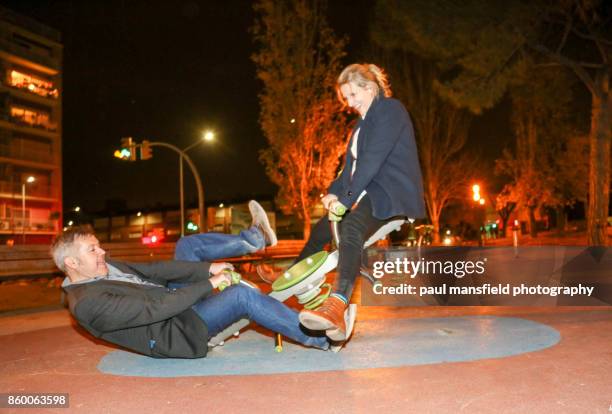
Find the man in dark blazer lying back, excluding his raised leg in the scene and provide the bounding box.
[51,204,354,358]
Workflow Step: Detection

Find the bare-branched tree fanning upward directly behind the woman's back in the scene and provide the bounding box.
[375,50,475,243]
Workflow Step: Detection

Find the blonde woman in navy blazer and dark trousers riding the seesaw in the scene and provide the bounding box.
[298,63,425,341]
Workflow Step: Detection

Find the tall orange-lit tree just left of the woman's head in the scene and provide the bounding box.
[252,0,347,238]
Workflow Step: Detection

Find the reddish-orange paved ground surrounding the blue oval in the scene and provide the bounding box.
[0,306,612,414]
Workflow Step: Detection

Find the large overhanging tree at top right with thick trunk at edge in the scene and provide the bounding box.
[377,0,612,245]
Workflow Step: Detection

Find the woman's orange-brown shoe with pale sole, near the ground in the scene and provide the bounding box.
[300,296,347,334]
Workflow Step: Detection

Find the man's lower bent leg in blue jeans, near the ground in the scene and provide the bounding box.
[192,285,329,349]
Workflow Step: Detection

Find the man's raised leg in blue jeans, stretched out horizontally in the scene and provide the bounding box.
[174,227,266,262]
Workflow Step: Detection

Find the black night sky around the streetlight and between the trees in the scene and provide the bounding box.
[0,0,511,217]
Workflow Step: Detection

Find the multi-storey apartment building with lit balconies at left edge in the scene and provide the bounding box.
[0,6,63,244]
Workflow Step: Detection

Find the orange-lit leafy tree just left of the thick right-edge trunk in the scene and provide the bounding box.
[497,69,577,237]
